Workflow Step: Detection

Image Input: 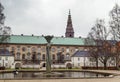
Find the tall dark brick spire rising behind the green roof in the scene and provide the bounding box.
[65,10,74,37]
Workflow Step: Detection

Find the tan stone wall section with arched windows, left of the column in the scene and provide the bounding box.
[8,44,46,60]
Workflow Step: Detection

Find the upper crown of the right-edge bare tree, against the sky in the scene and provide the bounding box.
[109,4,120,40]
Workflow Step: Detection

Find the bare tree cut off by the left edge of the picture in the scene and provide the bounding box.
[0,3,11,48]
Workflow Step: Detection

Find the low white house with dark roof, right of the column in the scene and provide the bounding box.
[71,50,116,68]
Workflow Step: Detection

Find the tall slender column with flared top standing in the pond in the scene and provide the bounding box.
[45,36,53,73]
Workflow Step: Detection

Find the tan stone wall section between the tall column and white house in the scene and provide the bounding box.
[51,45,84,62]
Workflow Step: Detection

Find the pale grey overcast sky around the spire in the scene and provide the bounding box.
[0,0,120,37]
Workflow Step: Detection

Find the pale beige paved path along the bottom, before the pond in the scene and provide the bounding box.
[0,78,120,82]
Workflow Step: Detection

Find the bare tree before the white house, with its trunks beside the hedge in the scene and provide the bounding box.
[88,19,111,69]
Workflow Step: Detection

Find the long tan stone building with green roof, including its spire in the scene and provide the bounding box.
[0,11,90,68]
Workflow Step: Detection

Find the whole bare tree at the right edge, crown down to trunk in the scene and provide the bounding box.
[109,4,120,69]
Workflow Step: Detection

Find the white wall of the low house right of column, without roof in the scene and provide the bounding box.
[71,57,116,68]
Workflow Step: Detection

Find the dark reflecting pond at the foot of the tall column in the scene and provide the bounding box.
[0,72,110,79]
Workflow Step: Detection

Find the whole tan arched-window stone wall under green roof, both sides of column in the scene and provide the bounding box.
[1,44,90,67]
